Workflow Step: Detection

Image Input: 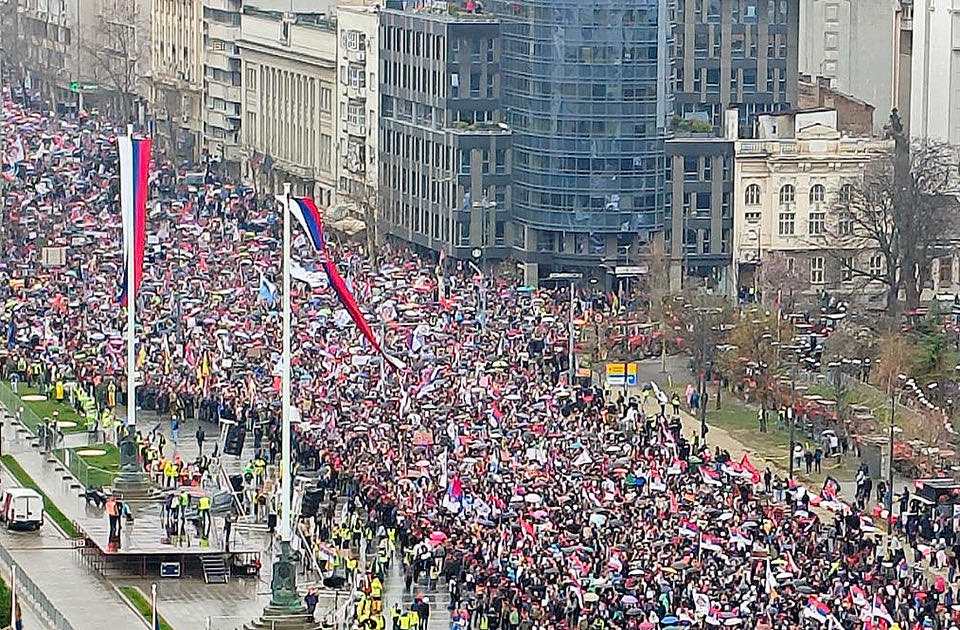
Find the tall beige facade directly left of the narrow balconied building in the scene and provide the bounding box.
[150,0,204,160]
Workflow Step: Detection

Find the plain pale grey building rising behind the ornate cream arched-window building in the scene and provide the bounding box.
[799,0,899,132]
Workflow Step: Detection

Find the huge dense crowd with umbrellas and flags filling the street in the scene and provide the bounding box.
[0,91,960,630]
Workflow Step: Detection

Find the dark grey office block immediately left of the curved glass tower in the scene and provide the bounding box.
[376,2,511,261]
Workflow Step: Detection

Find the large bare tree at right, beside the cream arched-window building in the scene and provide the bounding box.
[834,123,960,316]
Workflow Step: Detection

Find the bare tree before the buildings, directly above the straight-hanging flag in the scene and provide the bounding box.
[81,0,150,122]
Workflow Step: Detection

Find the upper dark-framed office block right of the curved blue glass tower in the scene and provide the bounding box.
[673,0,799,135]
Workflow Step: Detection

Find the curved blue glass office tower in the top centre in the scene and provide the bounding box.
[492,0,673,281]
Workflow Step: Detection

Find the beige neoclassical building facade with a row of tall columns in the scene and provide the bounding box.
[238,7,337,202]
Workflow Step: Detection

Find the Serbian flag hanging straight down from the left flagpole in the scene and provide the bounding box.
[117,136,150,305]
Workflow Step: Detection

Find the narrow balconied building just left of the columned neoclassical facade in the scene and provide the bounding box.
[202,0,244,174]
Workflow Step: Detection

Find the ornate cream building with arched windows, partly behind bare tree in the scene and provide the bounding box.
[733,109,893,307]
